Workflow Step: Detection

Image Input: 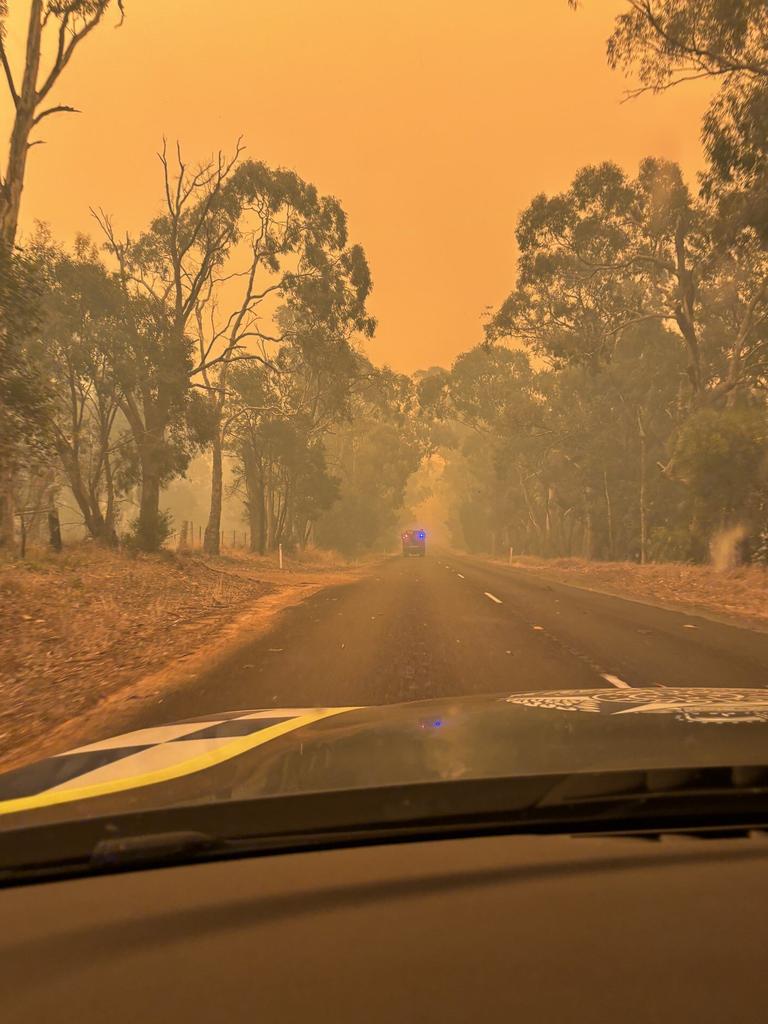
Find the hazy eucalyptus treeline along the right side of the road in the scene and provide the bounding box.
[420,0,768,561]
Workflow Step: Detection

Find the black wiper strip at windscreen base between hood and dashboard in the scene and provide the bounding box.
[0,766,768,885]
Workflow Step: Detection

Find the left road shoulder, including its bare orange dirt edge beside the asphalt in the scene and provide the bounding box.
[0,548,374,769]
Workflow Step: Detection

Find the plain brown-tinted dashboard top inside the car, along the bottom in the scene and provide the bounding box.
[0,835,768,1024]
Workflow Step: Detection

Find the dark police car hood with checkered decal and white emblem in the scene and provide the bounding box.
[0,687,768,828]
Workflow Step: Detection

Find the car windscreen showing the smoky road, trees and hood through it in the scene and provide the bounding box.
[0,0,768,827]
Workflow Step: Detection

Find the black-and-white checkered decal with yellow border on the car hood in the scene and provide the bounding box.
[0,708,345,812]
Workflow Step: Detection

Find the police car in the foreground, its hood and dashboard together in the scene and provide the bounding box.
[0,687,768,1024]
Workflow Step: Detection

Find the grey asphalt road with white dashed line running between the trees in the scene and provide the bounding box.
[124,552,768,727]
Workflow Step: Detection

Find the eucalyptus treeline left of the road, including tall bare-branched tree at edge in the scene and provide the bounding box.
[0,0,421,554]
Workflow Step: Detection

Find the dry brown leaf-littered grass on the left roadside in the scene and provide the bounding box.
[0,545,360,764]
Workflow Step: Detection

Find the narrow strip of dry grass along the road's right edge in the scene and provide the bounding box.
[495,556,768,626]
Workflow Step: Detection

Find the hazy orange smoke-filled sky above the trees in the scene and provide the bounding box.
[2,0,707,371]
